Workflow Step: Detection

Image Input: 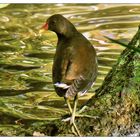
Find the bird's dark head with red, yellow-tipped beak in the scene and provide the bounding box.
[42,14,76,36]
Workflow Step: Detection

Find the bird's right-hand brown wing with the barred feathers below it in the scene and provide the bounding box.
[65,46,97,98]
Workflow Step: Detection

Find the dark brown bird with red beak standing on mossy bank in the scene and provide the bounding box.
[42,14,98,136]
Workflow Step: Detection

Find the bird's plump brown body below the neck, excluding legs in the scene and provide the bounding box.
[53,32,97,96]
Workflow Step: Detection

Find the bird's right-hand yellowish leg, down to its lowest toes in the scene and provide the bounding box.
[70,94,81,136]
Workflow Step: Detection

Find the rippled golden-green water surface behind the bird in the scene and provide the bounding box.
[0,4,140,120]
